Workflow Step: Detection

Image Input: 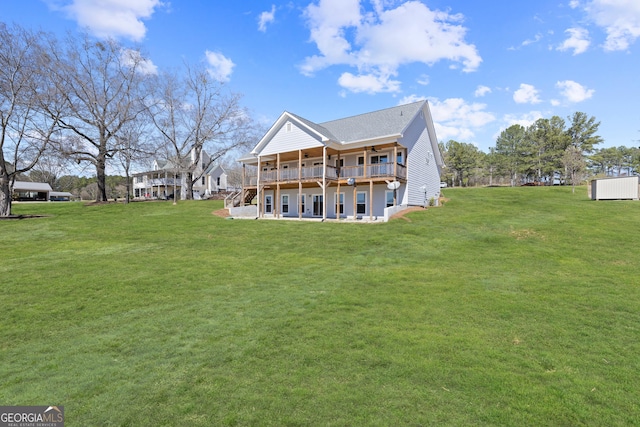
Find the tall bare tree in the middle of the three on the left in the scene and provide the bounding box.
[42,34,144,201]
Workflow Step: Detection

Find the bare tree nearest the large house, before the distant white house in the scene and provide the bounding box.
[147,66,257,199]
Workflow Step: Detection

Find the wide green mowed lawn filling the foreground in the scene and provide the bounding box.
[0,187,640,426]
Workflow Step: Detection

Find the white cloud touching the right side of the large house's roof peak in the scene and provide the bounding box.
[428,98,496,142]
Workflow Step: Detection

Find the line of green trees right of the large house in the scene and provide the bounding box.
[440,112,640,190]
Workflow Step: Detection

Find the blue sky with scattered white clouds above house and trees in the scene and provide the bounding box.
[0,0,640,152]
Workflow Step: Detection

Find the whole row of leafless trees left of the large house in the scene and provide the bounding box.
[0,22,262,216]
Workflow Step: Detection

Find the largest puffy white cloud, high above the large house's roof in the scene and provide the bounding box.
[300,0,482,90]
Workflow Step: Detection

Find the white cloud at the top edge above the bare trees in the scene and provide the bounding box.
[61,0,163,41]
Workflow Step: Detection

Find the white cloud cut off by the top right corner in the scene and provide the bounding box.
[585,0,640,51]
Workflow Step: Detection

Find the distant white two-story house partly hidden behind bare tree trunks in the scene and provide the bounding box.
[133,150,227,199]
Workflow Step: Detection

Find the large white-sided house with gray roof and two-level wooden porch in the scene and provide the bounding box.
[232,101,443,220]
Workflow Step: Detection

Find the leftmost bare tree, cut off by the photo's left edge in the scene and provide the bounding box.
[0,23,59,216]
